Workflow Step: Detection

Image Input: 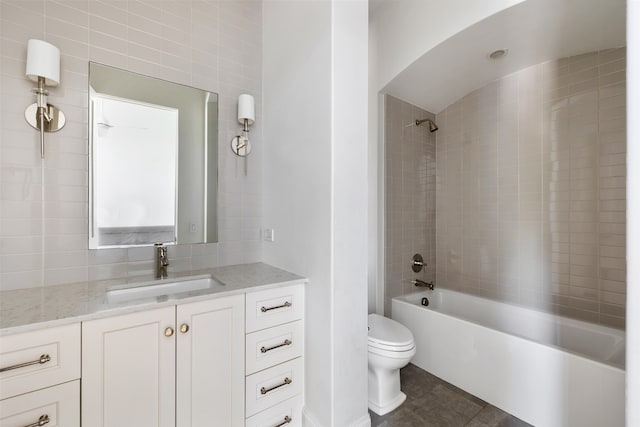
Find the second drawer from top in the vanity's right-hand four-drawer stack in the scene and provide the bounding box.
[246,320,304,375]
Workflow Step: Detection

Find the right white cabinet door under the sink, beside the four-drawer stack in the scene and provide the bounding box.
[176,295,244,427]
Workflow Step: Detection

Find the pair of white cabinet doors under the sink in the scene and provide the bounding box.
[82,295,244,427]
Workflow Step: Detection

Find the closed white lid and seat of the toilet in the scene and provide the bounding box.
[368,314,415,354]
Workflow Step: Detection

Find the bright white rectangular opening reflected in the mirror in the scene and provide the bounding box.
[91,93,178,246]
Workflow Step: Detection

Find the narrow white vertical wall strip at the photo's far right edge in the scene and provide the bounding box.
[627,0,640,427]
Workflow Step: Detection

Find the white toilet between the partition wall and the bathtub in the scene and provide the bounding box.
[368,314,416,415]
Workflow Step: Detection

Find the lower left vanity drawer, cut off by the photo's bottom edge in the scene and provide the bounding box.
[0,380,80,427]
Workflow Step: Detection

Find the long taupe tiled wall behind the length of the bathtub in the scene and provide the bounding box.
[436,48,626,328]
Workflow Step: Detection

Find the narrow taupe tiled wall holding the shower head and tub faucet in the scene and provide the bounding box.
[384,95,436,315]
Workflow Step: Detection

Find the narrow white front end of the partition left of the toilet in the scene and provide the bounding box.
[331,0,369,426]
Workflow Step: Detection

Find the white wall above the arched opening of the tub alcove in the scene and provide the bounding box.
[372,0,523,88]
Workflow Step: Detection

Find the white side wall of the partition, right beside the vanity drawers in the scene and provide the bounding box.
[263,1,332,425]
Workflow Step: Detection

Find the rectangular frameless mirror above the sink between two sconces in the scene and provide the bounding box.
[89,62,218,249]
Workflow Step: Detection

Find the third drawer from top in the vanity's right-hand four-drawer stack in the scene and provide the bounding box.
[245,357,304,417]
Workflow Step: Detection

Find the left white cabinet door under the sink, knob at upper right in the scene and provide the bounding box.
[82,306,176,427]
